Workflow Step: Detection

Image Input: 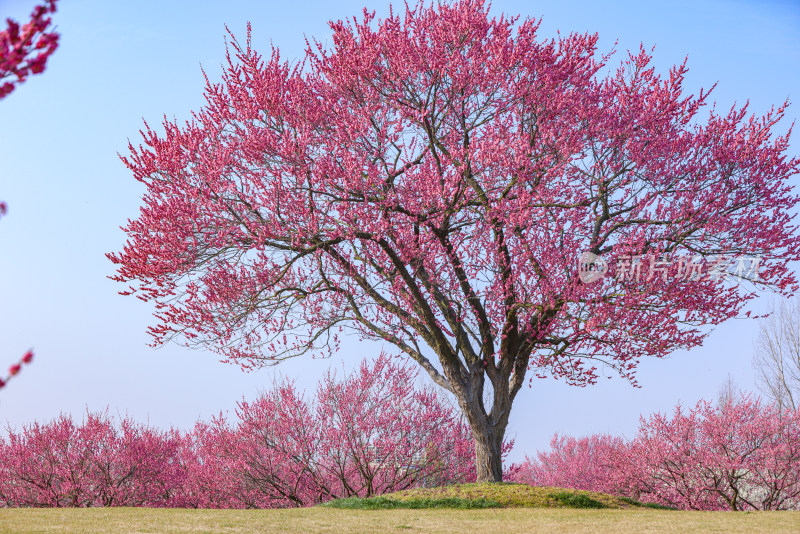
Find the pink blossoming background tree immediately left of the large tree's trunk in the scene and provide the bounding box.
[317,355,484,496]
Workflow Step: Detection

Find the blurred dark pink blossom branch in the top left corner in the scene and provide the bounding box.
[0,0,59,98]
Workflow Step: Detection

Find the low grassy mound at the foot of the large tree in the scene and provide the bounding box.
[323,482,668,510]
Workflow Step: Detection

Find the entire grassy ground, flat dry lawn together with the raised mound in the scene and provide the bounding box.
[0,484,800,534]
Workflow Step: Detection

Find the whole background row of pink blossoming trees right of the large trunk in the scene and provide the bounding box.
[508,395,800,510]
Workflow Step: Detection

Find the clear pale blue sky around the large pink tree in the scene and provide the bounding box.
[0,0,800,459]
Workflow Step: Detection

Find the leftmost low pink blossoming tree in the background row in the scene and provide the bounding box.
[0,413,187,507]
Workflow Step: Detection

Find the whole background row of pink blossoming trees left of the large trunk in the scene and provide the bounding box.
[0,355,494,508]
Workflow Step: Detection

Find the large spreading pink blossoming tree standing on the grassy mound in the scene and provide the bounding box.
[109,0,800,481]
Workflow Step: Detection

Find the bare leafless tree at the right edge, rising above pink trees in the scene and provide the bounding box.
[753,297,800,410]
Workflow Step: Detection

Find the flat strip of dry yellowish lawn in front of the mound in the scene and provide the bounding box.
[0,508,800,534]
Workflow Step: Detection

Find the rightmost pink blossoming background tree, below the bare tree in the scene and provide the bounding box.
[626,395,800,510]
